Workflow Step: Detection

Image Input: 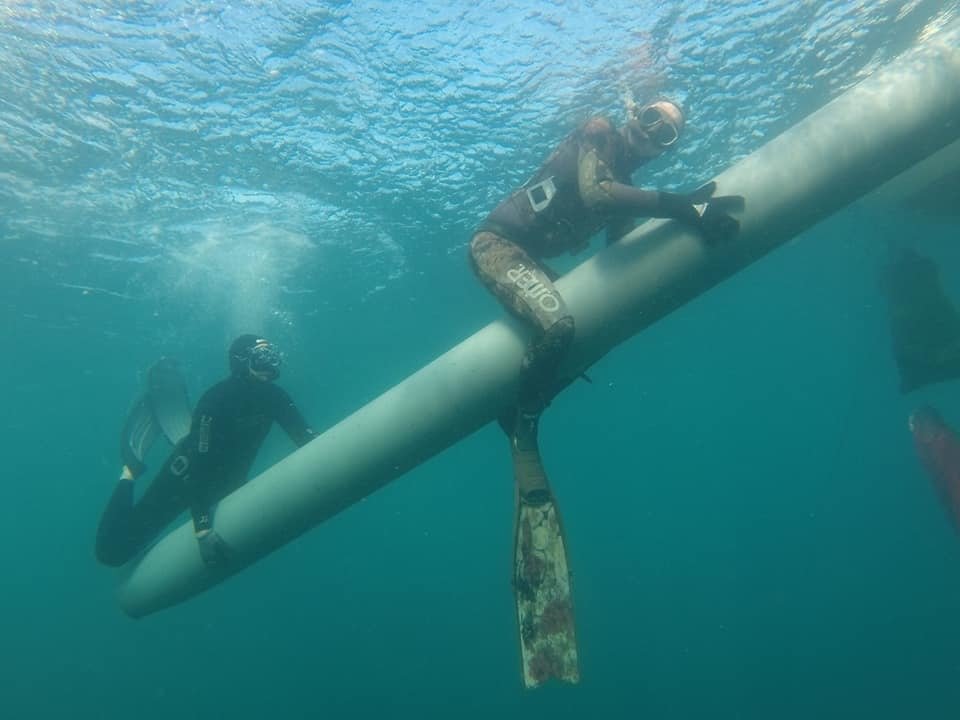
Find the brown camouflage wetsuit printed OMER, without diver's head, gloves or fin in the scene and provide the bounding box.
[470,117,674,411]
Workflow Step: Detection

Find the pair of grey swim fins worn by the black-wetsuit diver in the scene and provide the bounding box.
[120,358,191,477]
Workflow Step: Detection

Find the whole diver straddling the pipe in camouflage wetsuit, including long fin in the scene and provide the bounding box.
[470,99,743,687]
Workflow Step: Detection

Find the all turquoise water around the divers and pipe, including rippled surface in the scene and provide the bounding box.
[0,1,960,720]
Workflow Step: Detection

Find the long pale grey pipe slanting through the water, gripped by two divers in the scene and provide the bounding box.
[120,27,960,617]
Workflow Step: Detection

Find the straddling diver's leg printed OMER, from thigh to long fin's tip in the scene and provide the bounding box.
[470,232,580,688]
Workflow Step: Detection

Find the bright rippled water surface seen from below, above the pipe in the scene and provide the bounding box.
[0,1,956,326]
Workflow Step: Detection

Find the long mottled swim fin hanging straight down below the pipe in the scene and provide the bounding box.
[510,413,580,688]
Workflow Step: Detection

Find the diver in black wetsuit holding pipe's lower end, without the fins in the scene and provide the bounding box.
[96,335,316,566]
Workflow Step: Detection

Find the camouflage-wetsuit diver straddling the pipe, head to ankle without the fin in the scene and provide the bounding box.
[470,99,739,466]
